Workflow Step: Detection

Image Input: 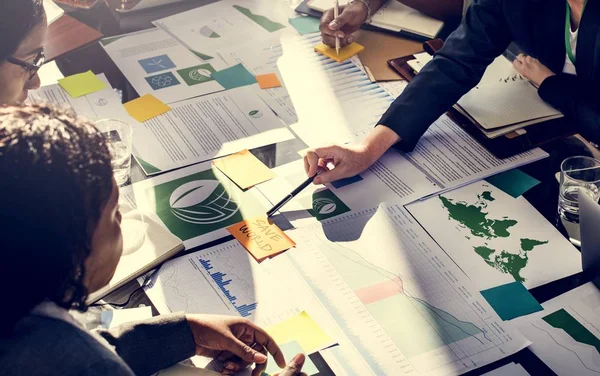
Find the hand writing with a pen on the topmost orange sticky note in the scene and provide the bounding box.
[319,1,367,47]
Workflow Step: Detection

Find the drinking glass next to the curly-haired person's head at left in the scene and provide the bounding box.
[96,119,133,186]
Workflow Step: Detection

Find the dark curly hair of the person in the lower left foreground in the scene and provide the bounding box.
[0,105,113,332]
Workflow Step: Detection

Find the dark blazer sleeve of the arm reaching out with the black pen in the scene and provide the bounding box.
[378,0,512,151]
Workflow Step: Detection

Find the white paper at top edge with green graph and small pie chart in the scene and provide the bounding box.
[154,0,289,60]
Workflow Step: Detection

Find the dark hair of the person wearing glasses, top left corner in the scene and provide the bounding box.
[0,0,46,63]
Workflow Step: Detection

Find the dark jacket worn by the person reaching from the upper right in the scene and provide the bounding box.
[379,0,600,151]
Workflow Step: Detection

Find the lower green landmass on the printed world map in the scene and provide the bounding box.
[474,239,548,282]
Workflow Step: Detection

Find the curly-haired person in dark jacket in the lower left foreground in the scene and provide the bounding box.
[0,106,304,376]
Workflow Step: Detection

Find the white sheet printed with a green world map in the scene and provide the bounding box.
[407,181,581,290]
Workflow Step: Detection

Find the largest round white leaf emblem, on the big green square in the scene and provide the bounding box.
[169,180,239,225]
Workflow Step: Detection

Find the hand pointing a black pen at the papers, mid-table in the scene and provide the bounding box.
[304,145,376,184]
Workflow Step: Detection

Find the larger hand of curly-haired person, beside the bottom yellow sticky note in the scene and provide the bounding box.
[186,315,285,376]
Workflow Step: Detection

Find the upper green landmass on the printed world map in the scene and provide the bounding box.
[439,191,518,239]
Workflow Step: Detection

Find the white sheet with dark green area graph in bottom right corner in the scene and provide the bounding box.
[512,282,600,376]
